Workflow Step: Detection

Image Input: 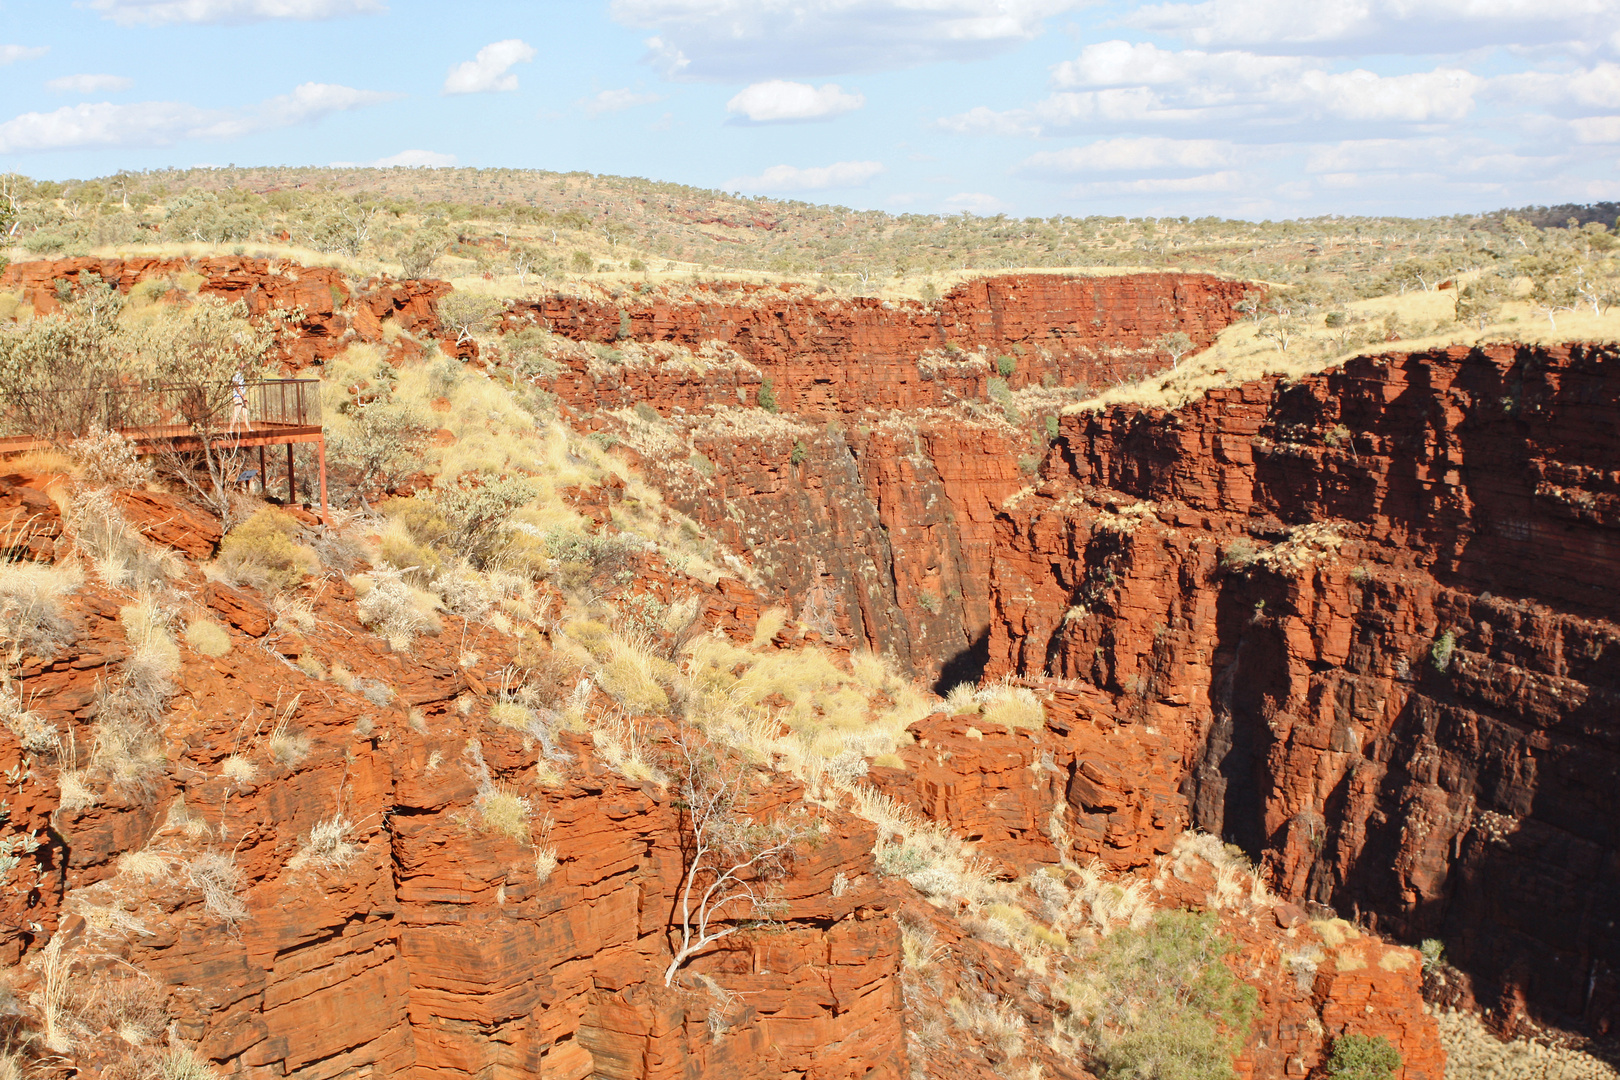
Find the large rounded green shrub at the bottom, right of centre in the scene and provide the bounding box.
[1087,912,1259,1080]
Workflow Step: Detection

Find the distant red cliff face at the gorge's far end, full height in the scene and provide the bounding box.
[537,274,1244,683]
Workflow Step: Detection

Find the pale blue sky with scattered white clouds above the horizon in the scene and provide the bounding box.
[0,0,1620,219]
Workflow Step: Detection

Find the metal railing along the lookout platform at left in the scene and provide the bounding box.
[0,379,321,442]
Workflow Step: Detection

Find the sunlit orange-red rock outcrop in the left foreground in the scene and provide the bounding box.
[9,553,906,1078]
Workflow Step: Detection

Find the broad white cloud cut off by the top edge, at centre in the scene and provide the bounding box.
[611,0,1095,79]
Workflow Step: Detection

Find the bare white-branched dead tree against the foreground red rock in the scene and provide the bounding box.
[664,732,808,986]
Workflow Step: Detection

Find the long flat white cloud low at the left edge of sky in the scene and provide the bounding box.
[0,83,399,154]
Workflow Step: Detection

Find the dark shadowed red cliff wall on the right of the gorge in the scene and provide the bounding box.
[990,347,1620,1030]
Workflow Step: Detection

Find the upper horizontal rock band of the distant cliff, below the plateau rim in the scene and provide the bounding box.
[518,274,1249,419]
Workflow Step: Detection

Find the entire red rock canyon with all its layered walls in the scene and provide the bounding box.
[0,257,1620,1080]
